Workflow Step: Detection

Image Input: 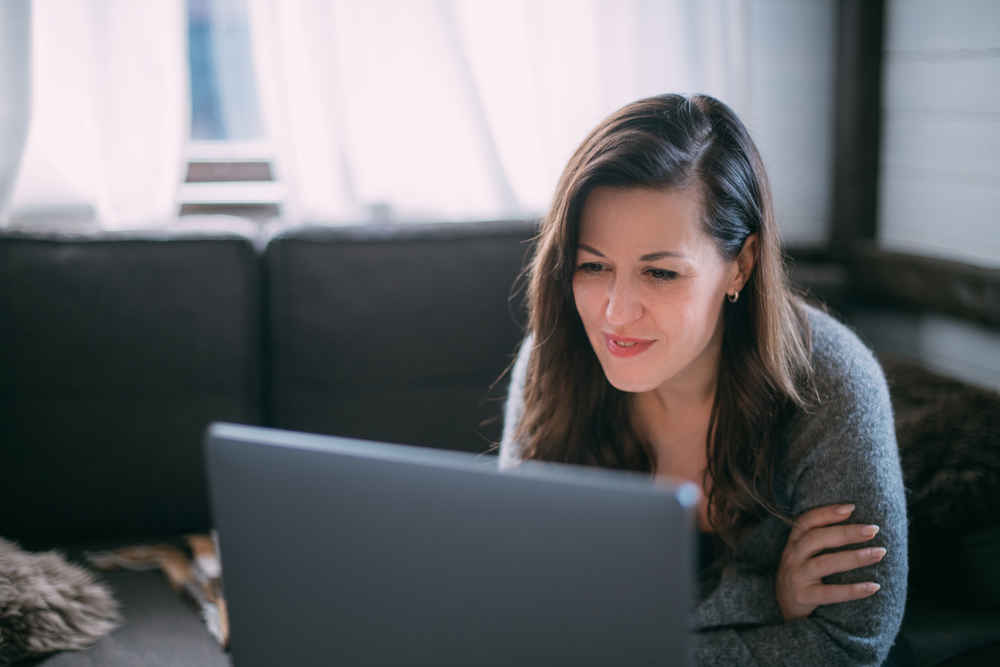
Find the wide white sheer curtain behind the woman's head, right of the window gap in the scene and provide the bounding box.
[248,0,750,221]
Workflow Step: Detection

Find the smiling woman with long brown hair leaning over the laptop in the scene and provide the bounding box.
[500,95,907,666]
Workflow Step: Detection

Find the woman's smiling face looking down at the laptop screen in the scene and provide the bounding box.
[573,187,749,392]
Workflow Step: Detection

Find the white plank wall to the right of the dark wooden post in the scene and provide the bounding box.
[878,0,1000,266]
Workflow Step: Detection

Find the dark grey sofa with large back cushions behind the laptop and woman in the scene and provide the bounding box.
[0,221,1000,667]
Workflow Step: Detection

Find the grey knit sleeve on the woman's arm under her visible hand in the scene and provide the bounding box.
[694,339,907,667]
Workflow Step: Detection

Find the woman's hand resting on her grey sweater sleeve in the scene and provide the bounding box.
[775,505,885,621]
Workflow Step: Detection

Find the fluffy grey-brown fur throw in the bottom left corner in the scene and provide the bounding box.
[0,539,121,666]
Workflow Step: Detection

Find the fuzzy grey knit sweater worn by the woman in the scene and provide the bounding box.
[500,306,907,667]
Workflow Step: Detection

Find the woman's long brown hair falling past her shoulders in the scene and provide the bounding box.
[515,95,815,548]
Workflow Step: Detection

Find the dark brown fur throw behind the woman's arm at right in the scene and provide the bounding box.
[883,361,1000,608]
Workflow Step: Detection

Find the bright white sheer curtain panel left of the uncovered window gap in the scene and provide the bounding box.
[8,0,190,228]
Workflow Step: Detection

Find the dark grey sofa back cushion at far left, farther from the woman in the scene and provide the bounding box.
[0,233,261,547]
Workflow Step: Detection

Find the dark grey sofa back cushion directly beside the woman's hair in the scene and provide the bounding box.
[266,222,535,451]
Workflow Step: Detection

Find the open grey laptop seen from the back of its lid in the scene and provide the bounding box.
[205,423,698,667]
